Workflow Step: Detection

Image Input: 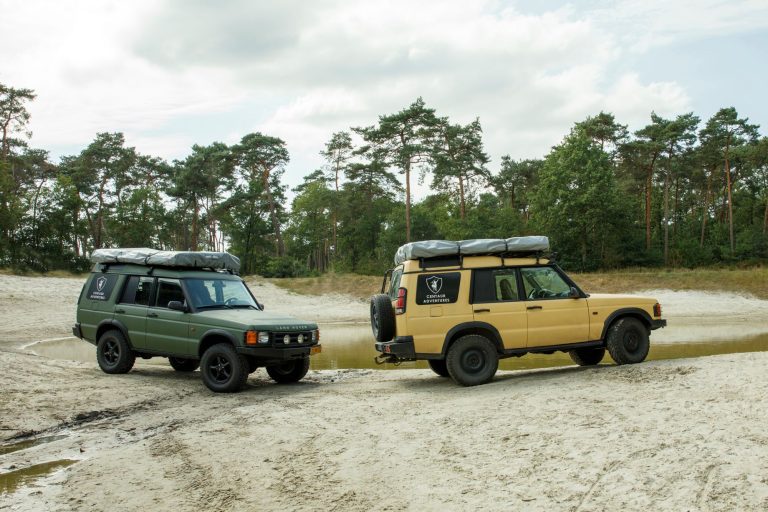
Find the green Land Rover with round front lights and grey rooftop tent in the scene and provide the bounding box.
[72,249,321,392]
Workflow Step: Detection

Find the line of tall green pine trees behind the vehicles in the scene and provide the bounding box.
[0,84,768,276]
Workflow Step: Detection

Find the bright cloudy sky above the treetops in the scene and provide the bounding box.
[0,0,768,196]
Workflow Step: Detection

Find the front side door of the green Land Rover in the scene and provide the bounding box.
[147,277,192,357]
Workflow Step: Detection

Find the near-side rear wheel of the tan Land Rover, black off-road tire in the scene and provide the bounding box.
[445,334,499,386]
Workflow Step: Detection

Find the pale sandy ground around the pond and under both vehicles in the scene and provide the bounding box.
[0,276,768,511]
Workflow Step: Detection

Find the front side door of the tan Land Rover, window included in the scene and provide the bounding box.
[520,267,589,347]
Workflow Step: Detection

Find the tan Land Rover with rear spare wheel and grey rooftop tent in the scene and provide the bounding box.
[371,236,667,386]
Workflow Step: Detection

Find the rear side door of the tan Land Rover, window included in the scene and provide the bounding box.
[472,268,528,349]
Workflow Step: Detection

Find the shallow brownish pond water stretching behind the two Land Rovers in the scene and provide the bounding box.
[30,324,768,370]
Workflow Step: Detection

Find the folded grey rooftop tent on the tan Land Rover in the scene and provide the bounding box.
[395,236,549,265]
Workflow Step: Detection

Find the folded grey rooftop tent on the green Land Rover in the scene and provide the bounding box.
[91,247,240,272]
